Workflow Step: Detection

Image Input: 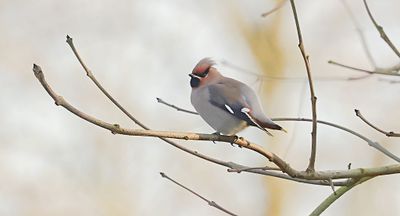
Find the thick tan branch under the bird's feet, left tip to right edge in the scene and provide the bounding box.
[33,64,400,181]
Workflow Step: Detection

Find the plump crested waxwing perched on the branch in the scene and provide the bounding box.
[189,58,286,136]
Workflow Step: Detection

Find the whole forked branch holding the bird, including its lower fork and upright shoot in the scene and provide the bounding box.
[33,33,400,213]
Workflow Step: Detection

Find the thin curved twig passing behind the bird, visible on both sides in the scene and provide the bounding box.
[157,98,400,163]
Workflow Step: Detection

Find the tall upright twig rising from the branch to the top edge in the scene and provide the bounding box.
[290,0,317,172]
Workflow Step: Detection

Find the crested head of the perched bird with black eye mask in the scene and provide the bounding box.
[189,58,219,88]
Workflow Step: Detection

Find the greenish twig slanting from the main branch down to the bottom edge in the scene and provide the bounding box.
[310,176,373,216]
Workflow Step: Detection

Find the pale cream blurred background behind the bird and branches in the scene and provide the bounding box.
[0,0,400,216]
